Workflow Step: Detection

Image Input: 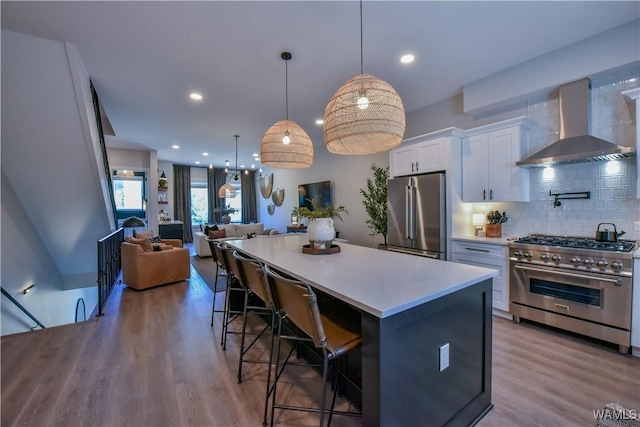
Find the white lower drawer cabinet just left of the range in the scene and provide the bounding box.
[451,239,510,317]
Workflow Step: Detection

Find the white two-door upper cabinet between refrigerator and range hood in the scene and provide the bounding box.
[462,117,531,202]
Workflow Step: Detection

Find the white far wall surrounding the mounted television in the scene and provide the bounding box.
[256,144,389,247]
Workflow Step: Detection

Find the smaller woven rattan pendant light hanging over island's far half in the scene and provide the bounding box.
[260,52,313,169]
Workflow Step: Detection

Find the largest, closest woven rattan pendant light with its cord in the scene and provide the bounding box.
[324,0,405,154]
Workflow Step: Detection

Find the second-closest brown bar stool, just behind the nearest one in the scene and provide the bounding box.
[233,251,281,426]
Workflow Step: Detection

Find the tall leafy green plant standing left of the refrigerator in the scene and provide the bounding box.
[360,163,389,248]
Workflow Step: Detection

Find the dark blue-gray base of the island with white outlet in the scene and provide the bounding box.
[362,279,493,427]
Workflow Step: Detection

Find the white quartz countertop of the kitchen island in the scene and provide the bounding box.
[225,234,498,318]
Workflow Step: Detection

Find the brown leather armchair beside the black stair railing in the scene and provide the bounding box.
[121,239,190,290]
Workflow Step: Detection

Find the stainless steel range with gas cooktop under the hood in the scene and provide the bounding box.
[509,235,636,353]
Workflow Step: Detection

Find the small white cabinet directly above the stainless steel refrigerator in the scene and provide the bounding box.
[390,138,447,177]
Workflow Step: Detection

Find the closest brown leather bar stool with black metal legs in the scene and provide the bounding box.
[264,266,362,427]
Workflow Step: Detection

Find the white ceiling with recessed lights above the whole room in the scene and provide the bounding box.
[1,0,640,166]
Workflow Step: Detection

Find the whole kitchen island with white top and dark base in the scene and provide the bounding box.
[226,235,497,426]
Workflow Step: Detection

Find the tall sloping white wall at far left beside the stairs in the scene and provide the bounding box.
[2,30,112,289]
